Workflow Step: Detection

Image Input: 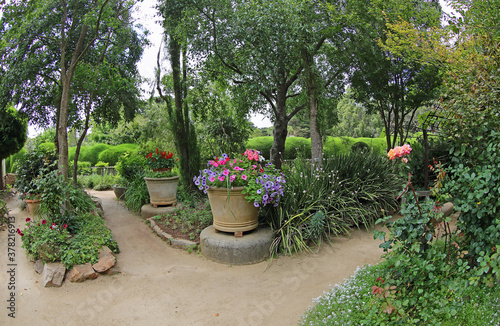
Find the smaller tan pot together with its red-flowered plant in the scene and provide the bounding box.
[144,148,179,207]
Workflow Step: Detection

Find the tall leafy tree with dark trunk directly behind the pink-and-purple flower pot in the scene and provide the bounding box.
[188,0,332,167]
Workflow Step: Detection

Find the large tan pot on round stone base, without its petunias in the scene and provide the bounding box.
[207,187,259,236]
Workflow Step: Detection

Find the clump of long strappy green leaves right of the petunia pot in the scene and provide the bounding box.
[263,152,399,253]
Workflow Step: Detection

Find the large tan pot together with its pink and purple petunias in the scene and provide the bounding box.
[193,149,285,236]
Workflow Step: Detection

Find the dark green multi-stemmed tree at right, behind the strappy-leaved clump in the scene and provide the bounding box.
[349,0,441,148]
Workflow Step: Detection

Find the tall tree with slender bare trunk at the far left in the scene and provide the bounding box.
[0,0,142,178]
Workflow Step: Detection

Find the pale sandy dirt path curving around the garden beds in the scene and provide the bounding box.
[0,191,382,326]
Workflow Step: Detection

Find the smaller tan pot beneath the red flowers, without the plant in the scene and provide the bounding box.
[144,176,179,207]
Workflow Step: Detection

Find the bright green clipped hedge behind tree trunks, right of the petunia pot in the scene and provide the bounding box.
[247,136,387,160]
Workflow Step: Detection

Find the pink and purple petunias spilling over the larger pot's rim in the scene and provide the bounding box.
[193,149,286,207]
